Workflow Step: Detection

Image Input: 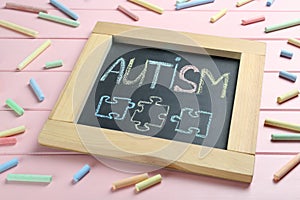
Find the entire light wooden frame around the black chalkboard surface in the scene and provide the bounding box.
[39,22,265,183]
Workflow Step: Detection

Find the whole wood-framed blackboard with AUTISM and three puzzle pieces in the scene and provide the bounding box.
[38,22,266,183]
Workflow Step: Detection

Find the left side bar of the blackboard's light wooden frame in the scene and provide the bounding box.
[49,34,112,122]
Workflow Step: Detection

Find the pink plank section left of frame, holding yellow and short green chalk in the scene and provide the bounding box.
[0,39,86,73]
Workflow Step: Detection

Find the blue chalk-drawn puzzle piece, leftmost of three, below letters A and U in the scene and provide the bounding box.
[95,95,135,120]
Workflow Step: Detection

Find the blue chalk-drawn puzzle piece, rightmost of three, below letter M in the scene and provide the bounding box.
[170,108,212,138]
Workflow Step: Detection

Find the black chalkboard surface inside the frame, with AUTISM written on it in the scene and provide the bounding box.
[77,43,240,149]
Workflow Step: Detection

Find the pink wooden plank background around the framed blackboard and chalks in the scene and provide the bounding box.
[0,0,300,200]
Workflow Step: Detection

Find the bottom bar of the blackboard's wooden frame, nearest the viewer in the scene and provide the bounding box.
[39,120,254,183]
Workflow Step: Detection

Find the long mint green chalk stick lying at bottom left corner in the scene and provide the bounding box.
[6,174,52,183]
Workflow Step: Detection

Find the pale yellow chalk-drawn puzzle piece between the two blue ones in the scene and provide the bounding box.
[131,96,169,131]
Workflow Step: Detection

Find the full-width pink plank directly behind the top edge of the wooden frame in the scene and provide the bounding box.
[0,9,299,39]
